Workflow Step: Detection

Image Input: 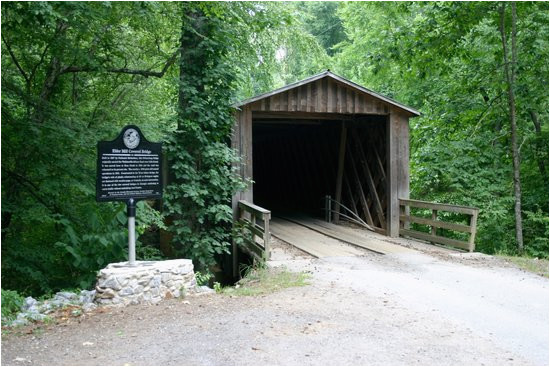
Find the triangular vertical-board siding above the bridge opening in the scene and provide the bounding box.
[250,77,390,115]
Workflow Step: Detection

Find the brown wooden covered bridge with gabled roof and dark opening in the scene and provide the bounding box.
[232,70,473,274]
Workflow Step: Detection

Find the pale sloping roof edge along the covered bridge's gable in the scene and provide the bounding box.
[233,70,420,116]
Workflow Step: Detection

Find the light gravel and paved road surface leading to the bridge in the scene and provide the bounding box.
[2,240,549,365]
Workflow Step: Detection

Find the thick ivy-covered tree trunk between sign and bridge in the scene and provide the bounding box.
[165,3,274,269]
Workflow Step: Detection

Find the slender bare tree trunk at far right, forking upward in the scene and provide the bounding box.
[500,2,523,252]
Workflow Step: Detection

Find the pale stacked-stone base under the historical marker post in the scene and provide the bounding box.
[94,259,197,306]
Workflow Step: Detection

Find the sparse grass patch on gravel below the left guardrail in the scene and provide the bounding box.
[222,268,309,296]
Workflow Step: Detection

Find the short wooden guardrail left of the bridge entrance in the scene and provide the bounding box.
[239,200,271,261]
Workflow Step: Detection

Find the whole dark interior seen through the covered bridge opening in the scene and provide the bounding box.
[252,115,386,228]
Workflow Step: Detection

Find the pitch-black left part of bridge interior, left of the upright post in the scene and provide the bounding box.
[253,120,340,216]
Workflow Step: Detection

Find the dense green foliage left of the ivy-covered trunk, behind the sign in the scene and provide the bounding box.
[2,2,176,296]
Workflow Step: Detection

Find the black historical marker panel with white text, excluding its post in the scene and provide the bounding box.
[96,125,162,201]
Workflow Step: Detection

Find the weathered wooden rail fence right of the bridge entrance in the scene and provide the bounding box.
[399,199,479,252]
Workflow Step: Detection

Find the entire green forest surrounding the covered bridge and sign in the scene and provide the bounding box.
[1,1,549,298]
